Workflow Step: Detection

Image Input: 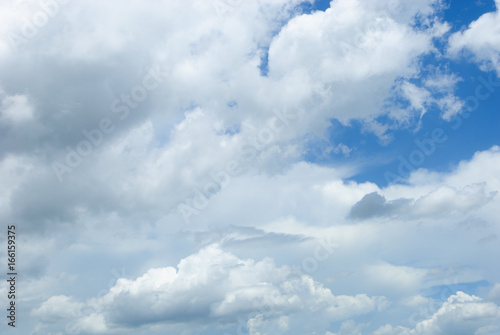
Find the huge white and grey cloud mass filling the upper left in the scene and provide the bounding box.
[0,0,468,236]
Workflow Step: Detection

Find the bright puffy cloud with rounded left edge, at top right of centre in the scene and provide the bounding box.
[269,1,453,137]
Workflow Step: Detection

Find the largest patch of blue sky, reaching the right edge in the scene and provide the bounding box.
[305,70,500,186]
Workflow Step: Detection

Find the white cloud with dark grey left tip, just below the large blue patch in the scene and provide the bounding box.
[348,146,500,219]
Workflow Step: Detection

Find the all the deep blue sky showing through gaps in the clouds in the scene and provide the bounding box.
[305,1,500,186]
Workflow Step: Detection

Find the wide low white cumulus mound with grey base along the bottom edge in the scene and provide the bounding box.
[32,245,389,332]
